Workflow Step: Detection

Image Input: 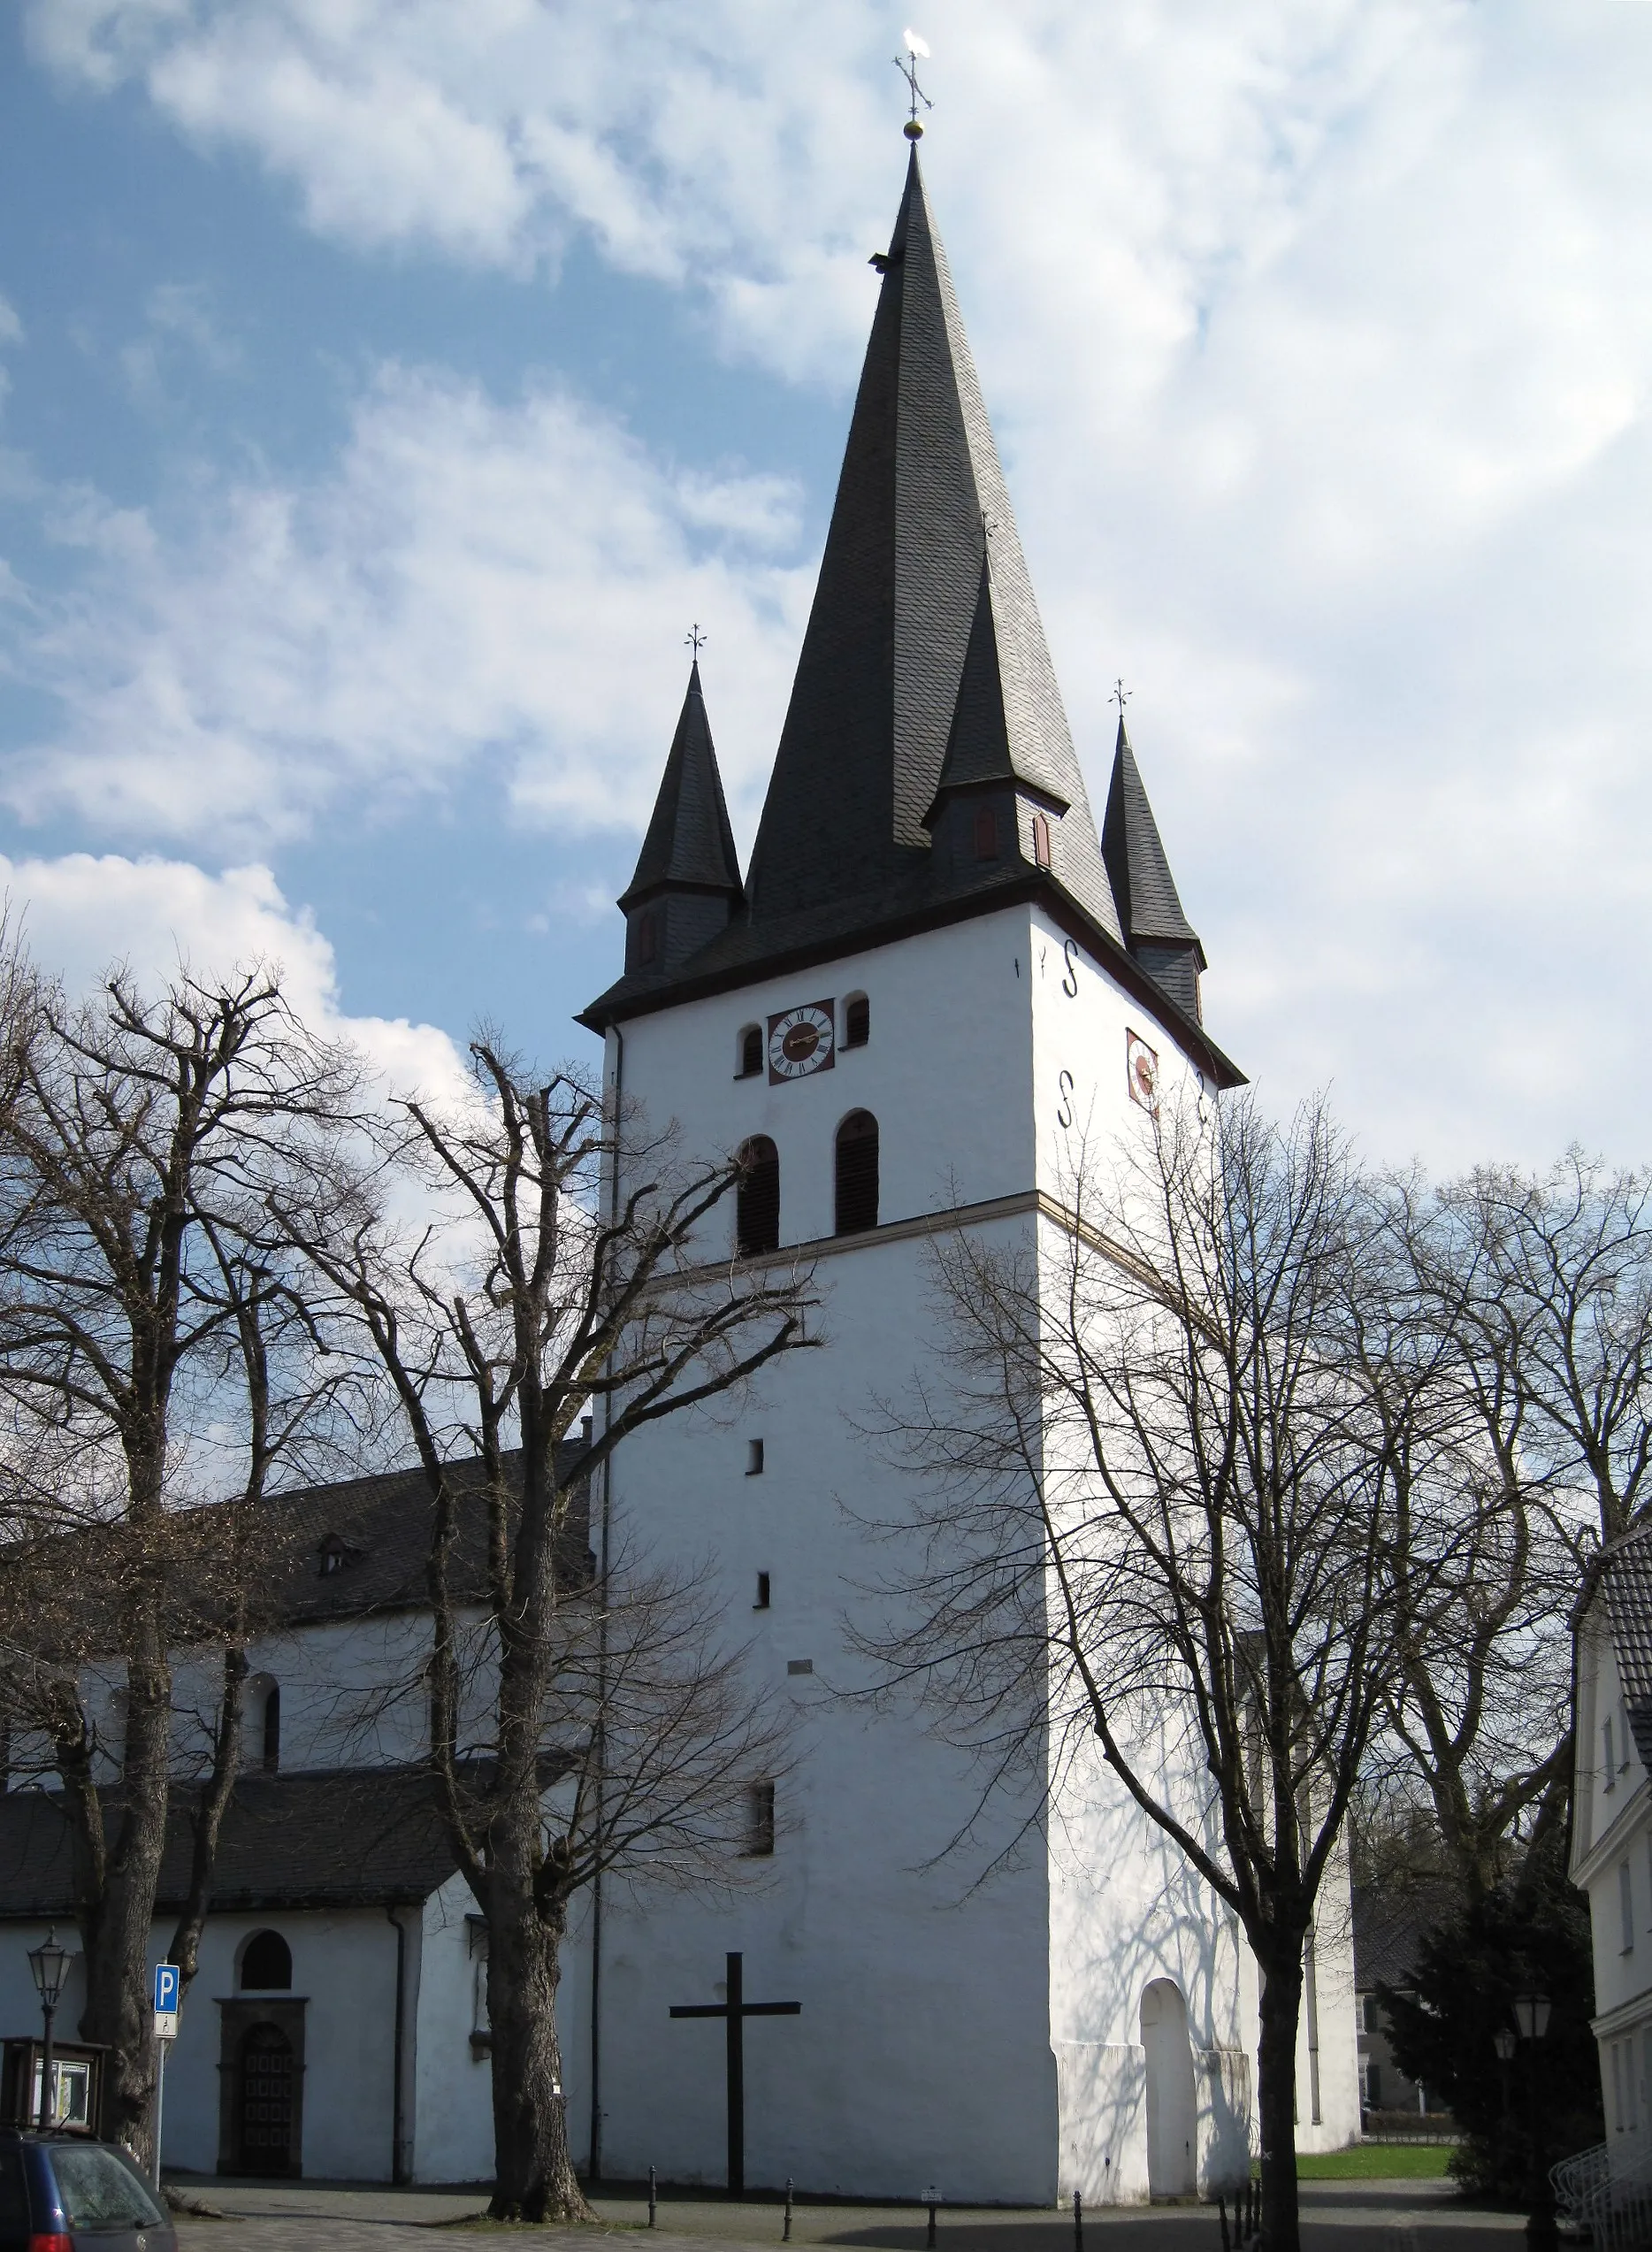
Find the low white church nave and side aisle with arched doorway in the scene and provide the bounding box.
[0,1448,587,2182]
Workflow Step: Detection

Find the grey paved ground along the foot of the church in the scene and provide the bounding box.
[165,2180,1524,2252]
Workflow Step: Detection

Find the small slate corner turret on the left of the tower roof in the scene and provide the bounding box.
[619,657,740,975]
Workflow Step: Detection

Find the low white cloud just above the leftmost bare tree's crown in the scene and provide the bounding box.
[0,854,463,1094]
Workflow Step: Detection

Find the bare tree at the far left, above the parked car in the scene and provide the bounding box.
[0,957,358,2150]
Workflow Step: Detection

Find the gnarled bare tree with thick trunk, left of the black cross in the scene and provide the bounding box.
[281,1038,813,2220]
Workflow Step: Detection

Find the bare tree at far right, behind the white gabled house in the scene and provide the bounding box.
[1359,1151,1652,1892]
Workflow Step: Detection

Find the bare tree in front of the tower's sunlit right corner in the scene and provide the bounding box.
[862,1099,1449,2252]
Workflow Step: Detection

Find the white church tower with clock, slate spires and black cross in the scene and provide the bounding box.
[567,144,1359,2202]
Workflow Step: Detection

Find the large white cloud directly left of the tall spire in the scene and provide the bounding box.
[4,367,808,849]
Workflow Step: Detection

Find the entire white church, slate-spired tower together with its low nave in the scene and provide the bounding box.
[0,136,1359,2205]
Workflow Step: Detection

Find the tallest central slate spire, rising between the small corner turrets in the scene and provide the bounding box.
[747,146,1120,944]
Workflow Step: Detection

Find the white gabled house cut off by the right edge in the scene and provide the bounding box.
[1571,1527,1652,2141]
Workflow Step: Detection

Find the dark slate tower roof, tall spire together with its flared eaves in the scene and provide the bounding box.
[581,146,1243,1085]
